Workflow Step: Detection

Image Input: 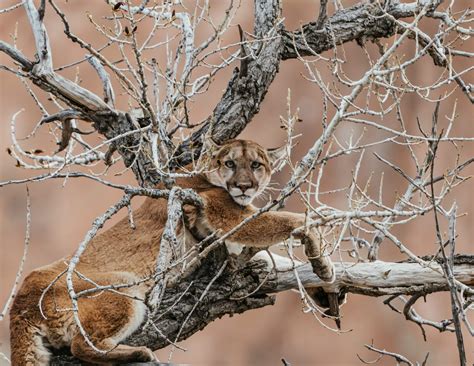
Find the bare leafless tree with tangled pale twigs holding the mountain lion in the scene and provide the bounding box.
[0,0,474,365]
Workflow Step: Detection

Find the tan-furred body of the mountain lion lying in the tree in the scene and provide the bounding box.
[10,140,334,365]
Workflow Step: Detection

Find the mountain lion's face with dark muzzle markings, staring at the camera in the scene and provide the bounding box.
[206,140,284,206]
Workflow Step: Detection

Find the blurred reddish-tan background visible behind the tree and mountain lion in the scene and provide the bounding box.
[0,0,474,365]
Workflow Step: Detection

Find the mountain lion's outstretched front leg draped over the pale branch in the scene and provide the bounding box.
[194,192,335,282]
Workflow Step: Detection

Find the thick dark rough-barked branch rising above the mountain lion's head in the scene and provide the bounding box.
[175,0,283,164]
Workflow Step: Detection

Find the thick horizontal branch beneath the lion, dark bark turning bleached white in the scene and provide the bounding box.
[51,250,474,364]
